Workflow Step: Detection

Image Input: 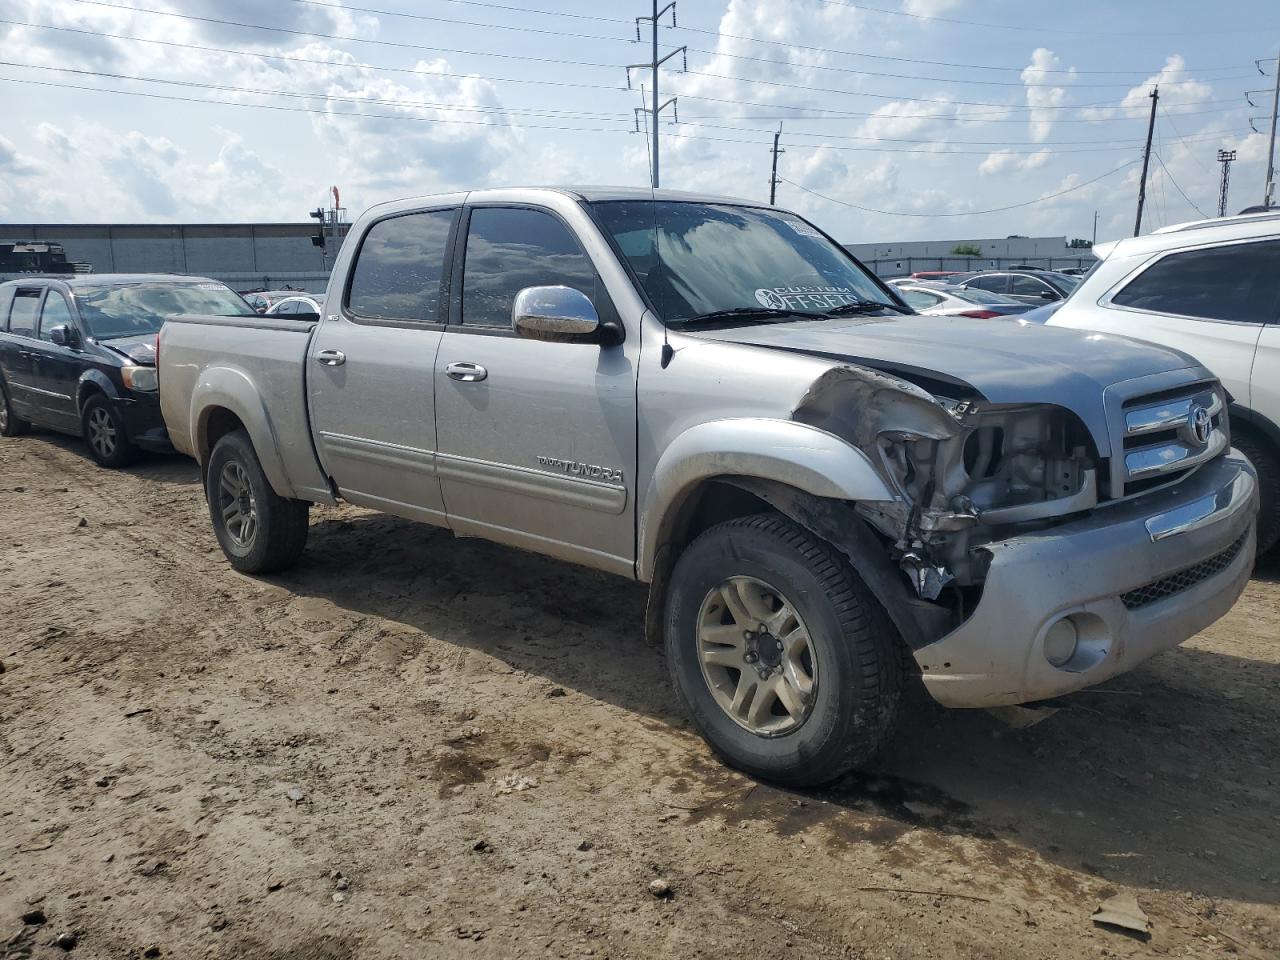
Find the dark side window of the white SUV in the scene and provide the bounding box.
[1111,241,1280,324]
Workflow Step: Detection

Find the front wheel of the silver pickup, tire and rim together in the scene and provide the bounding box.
[664,513,904,787]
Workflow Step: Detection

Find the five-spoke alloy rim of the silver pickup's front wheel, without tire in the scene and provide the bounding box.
[698,576,818,737]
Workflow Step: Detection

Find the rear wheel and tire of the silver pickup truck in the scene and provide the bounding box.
[205,430,311,573]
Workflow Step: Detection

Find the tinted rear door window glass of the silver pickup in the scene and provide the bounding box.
[347,210,457,323]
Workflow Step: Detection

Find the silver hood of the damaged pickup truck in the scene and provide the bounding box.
[694,315,1211,447]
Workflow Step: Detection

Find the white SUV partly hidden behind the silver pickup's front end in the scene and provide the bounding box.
[1046,210,1280,553]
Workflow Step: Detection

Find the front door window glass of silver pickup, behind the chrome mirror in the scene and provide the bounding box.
[462,207,595,329]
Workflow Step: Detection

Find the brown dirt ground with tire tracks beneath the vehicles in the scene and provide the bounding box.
[0,434,1280,960]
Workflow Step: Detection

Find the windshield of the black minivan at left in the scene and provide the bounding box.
[73,280,257,340]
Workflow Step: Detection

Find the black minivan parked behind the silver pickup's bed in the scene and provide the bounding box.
[0,274,253,467]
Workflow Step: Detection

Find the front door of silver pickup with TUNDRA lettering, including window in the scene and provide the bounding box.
[435,207,639,575]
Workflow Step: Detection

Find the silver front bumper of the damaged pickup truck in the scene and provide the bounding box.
[915,451,1258,707]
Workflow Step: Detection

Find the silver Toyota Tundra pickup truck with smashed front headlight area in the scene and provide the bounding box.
[159,189,1257,785]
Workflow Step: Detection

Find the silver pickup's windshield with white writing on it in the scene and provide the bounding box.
[591,200,902,323]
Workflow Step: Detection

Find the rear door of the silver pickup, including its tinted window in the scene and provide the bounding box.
[307,207,458,525]
